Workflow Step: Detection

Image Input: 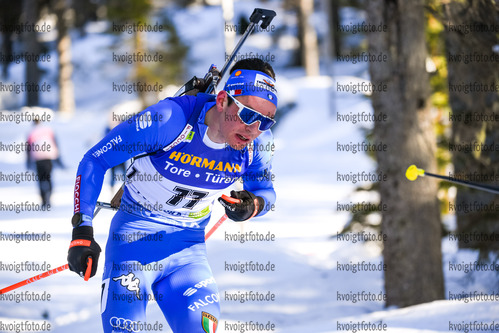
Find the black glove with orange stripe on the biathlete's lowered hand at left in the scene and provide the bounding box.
[68,226,101,277]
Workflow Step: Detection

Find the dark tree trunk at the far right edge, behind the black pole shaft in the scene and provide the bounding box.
[443,0,499,255]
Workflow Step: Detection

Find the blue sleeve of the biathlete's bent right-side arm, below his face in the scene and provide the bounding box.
[243,130,276,216]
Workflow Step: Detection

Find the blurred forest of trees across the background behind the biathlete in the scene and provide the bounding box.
[0,0,499,306]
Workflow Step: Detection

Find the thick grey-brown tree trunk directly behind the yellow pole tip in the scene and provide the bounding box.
[367,0,444,307]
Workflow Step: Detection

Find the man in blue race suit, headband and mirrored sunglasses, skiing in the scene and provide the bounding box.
[68,58,277,333]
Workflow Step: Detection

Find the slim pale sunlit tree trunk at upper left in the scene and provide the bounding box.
[54,0,75,114]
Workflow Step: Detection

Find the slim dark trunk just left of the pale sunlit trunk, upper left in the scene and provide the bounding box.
[23,0,40,106]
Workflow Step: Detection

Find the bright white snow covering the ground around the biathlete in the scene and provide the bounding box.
[0,1,499,333]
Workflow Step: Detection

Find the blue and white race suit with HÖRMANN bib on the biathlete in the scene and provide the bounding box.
[75,94,275,333]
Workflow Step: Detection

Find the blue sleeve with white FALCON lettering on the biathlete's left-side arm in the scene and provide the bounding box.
[74,99,187,225]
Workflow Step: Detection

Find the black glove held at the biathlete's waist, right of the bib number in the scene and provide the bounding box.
[218,190,265,222]
